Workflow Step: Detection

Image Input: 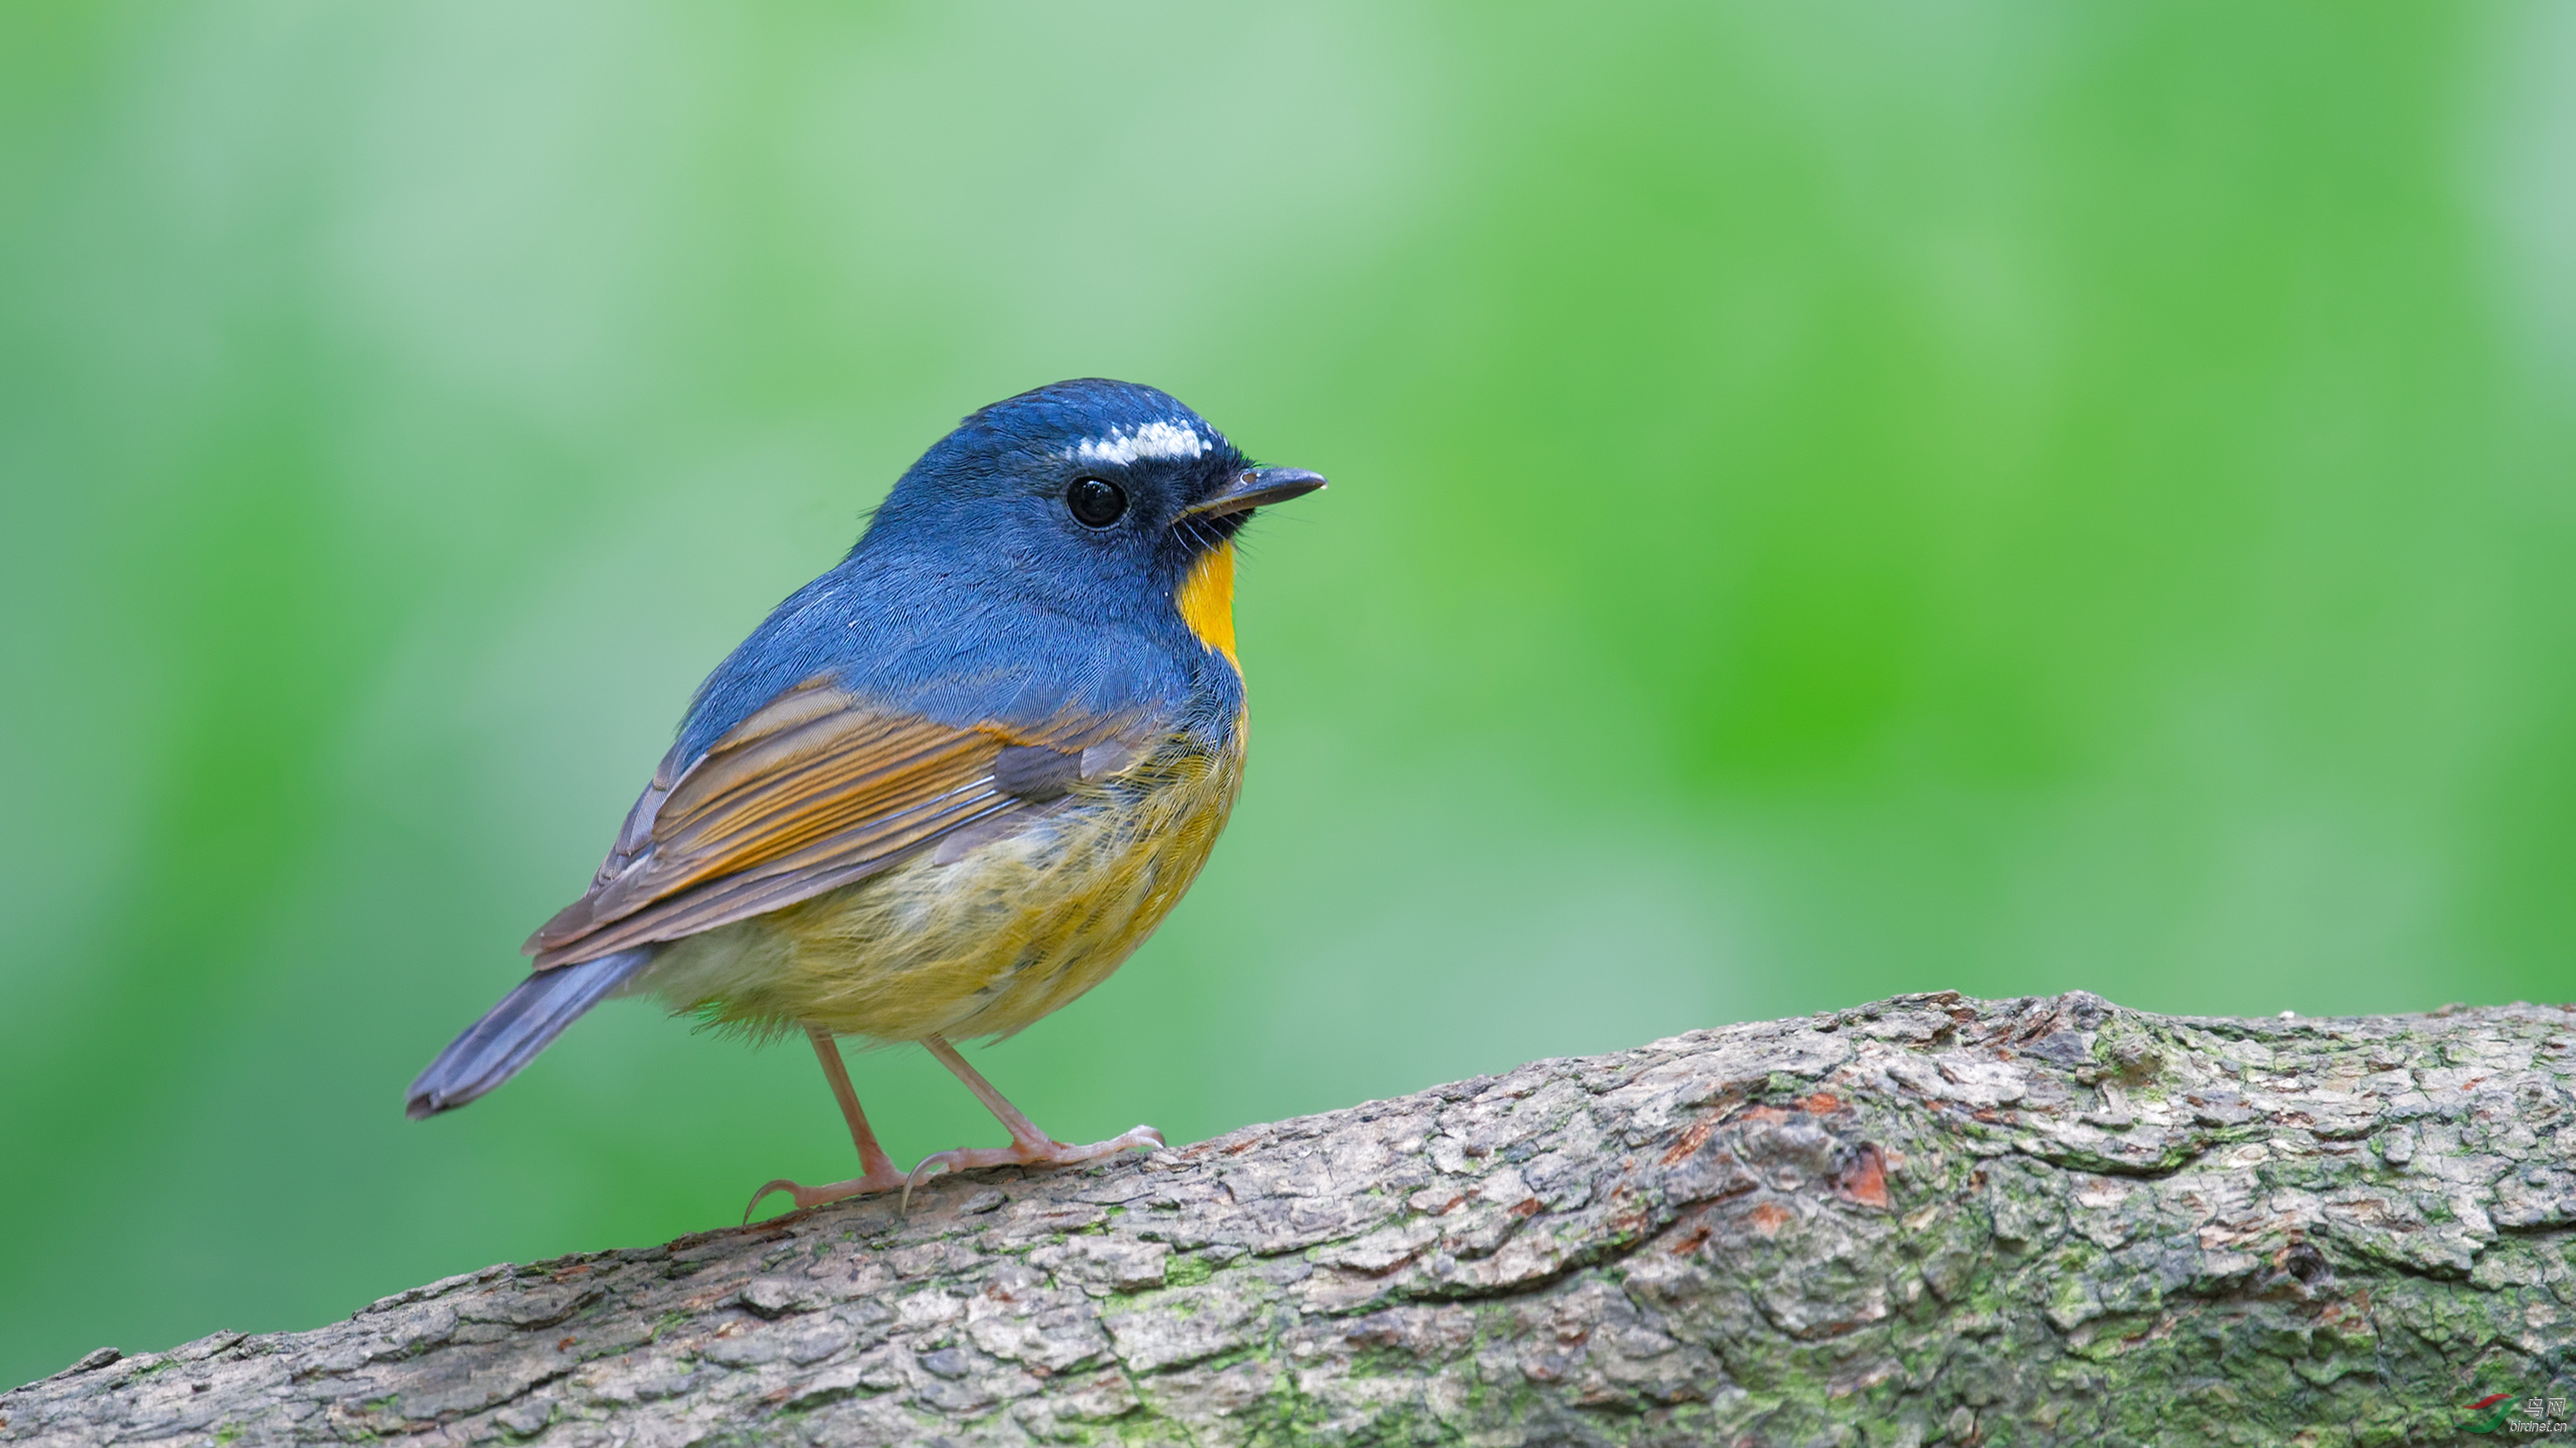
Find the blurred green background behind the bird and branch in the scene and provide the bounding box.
[0,0,2576,1384]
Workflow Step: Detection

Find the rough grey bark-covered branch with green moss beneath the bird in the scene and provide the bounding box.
[0,992,2576,1446]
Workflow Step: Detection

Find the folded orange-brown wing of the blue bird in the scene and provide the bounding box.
[528,680,1120,969]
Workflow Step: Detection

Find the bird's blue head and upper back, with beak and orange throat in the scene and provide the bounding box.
[680,379,1324,752]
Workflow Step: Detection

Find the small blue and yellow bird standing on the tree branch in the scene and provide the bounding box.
[405,379,1324,1222]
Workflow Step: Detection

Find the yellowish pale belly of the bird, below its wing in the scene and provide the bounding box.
[636,724,1244,1041]
